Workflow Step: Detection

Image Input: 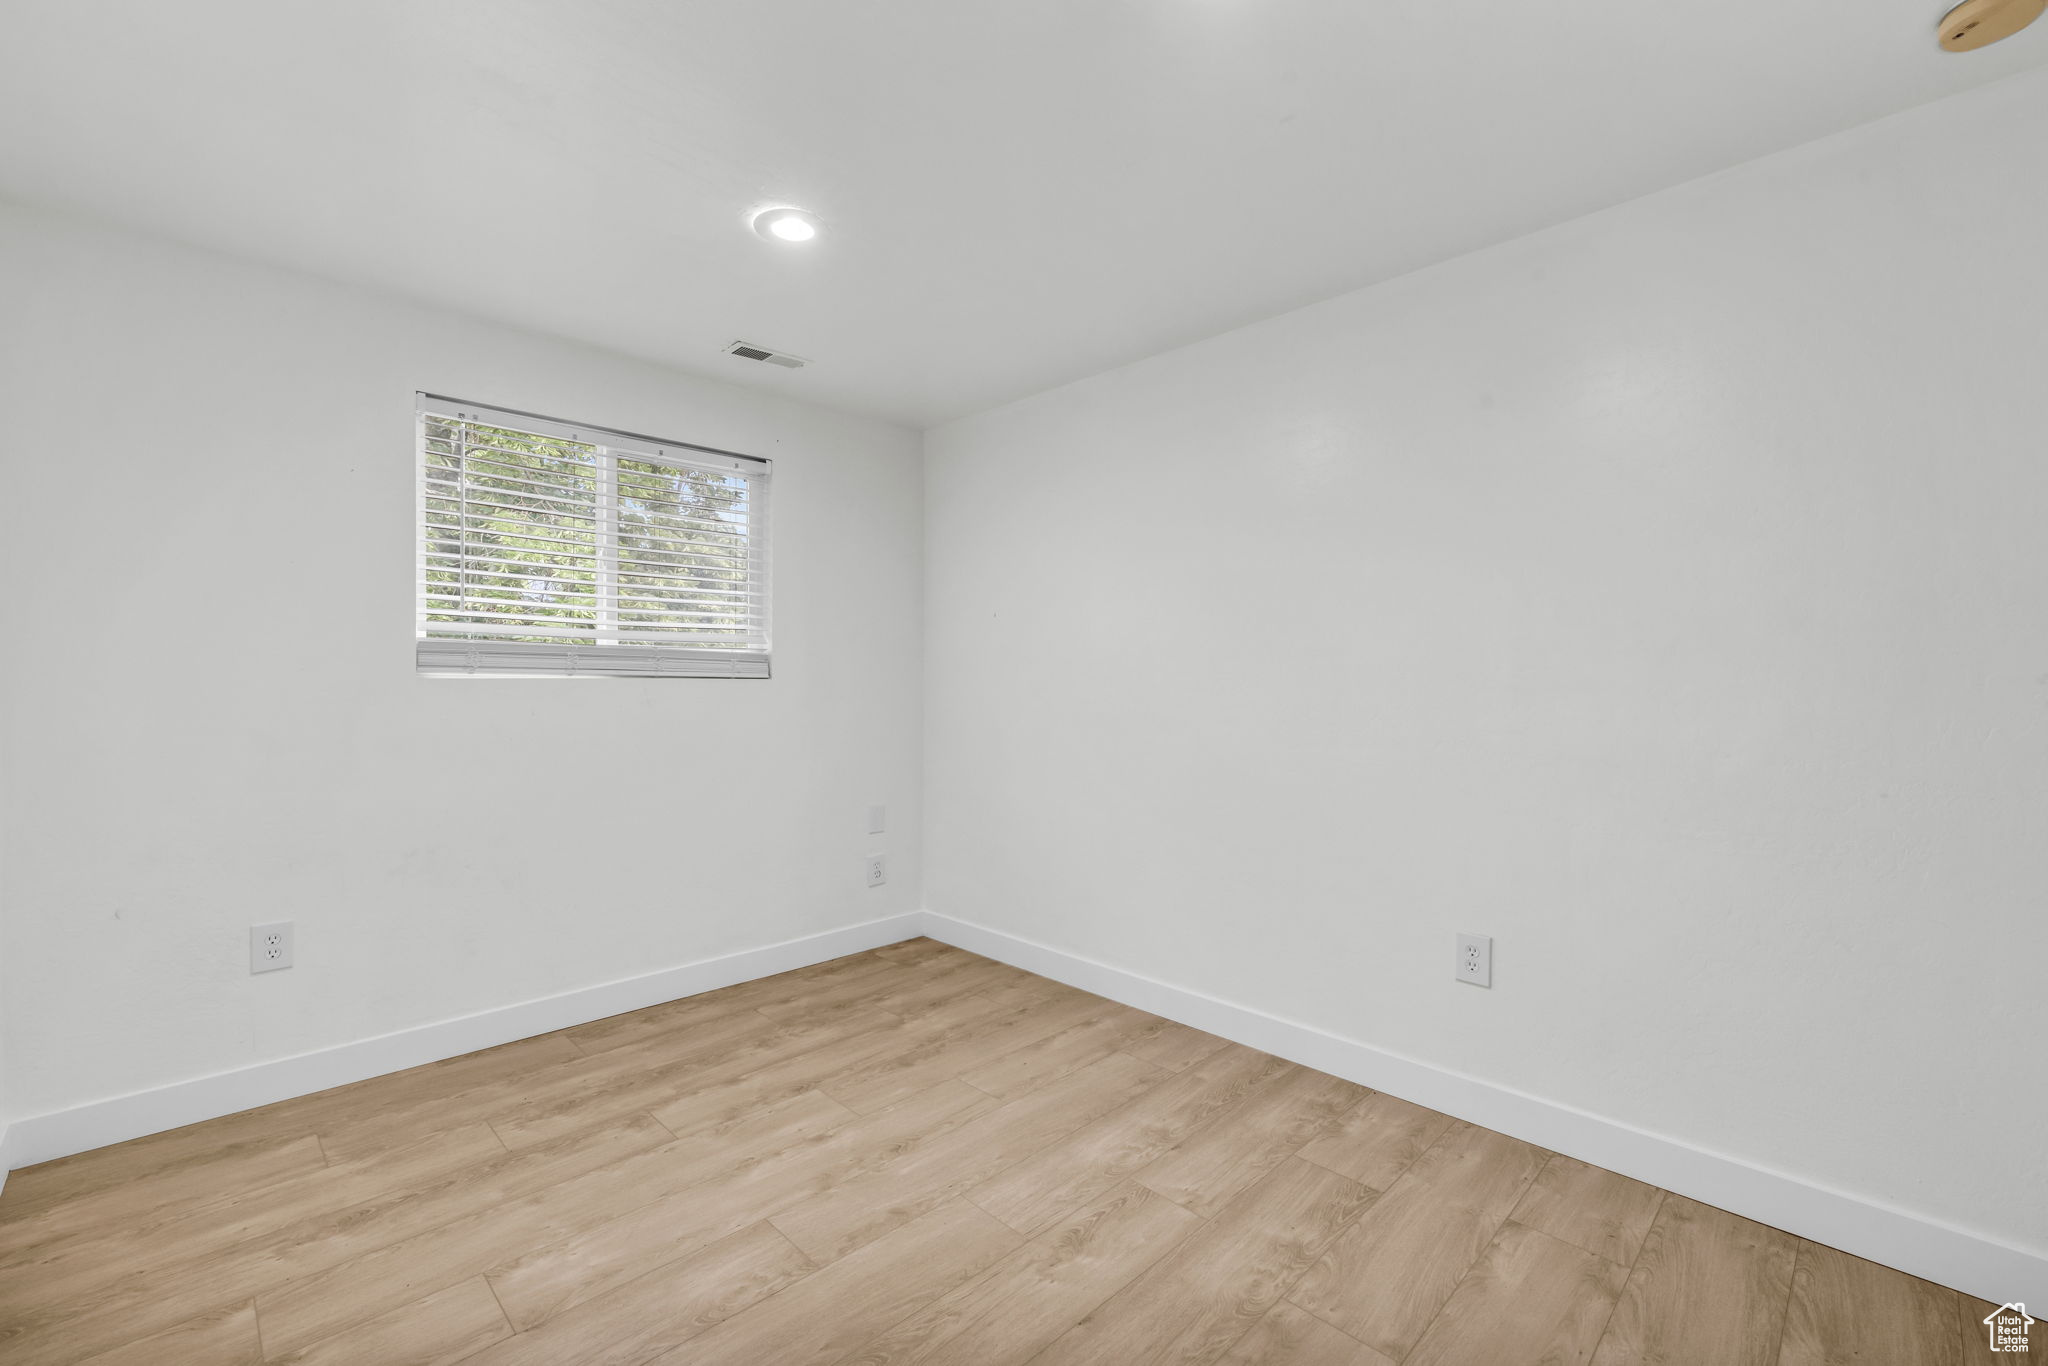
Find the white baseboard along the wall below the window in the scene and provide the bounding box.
[0,911,924,1171]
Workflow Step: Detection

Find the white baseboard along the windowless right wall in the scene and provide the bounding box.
[924,911,2048,1305]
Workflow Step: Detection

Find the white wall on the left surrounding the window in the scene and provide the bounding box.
[0,197,922,1118]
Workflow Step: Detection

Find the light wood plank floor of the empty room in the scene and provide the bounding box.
[0,940,2003,1366]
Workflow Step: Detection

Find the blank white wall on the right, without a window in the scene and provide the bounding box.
[926,63,2048,1251]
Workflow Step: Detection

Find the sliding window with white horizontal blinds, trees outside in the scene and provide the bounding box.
[418,393,768,678]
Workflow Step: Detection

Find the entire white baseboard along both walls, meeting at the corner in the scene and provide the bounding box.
[0,911,2048,1305]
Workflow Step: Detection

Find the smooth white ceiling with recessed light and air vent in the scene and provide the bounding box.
[0,0,2048,424]
